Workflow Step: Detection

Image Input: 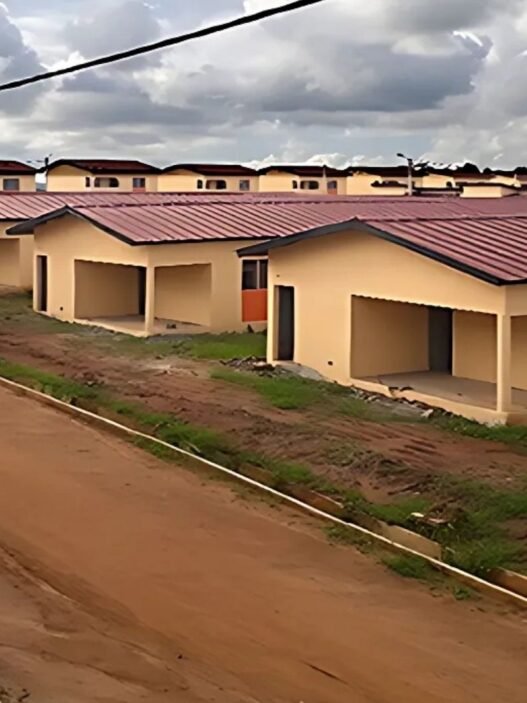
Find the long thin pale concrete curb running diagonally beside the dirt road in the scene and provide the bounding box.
[0,377,527,609]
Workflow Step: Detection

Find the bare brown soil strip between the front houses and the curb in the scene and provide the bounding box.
[0,326,527,502]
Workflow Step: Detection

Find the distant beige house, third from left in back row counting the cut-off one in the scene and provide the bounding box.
[158,164,258,193]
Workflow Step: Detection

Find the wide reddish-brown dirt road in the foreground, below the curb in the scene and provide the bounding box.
[0,390,527,703]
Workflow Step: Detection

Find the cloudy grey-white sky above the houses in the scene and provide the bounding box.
[0,0,527,166]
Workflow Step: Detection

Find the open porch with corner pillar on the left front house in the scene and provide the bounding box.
[75,260,211,337]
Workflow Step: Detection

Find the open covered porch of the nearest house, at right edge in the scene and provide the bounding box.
[351,296,527,424]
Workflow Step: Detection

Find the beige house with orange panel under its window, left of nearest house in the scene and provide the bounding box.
[9,193,374,336]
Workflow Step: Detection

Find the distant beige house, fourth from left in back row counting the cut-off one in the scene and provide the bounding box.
[258,164,346,195]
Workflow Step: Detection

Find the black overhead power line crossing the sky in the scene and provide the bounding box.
[0,0,325,92]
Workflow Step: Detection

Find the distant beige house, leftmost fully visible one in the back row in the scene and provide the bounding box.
[41,159,159,193]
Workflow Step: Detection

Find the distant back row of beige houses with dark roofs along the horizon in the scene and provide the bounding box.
[0,159,527,197]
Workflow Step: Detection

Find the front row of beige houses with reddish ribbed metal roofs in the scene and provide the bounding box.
[0,188,527,423]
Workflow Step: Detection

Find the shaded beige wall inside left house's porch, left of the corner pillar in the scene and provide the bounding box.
[75,261,139,319]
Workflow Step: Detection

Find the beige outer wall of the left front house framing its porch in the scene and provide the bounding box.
[31,217,254,332]
